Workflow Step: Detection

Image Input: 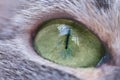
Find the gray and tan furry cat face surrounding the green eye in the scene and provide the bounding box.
[0,0,120,80]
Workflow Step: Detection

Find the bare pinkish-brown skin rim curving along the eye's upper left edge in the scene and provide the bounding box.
[30,12,75,36]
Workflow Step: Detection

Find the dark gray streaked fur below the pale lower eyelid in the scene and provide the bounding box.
[0,52,79,80]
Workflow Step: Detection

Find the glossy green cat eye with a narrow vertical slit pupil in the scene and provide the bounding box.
[34,19,105,67]
